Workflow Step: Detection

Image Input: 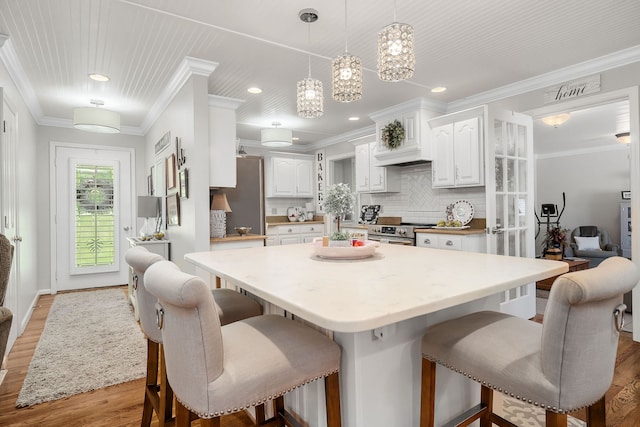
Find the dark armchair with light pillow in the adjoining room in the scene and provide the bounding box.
[569,225,620,268]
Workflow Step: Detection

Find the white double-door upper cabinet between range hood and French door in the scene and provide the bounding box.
[432,117,484,188]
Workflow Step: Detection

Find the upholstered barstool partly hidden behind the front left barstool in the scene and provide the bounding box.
[125,246,262,427]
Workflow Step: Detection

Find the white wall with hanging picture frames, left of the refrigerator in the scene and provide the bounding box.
[144,75,209,274]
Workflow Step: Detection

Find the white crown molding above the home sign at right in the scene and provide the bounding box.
[447,45,640,112]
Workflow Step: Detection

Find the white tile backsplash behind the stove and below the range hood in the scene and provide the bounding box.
[360,163,487,223]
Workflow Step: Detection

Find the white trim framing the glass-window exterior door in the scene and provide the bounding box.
[49,141,137,295]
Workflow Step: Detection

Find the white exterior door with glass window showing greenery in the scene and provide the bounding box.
[52,146,133,291]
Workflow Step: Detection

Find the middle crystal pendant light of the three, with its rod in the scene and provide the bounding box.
[331,0,362,102]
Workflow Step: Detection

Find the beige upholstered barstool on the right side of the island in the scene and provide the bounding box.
[420,257,640,427]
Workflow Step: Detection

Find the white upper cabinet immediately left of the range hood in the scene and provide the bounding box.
[355,142,400,193]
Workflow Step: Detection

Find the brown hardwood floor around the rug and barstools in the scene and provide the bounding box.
[0,295,640,427]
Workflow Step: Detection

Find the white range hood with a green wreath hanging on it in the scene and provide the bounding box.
[369,98,440,166]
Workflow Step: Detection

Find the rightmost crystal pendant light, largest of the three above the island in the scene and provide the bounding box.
[378,0,416,82]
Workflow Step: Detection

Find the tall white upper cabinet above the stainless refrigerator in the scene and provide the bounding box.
[209,95,244,187]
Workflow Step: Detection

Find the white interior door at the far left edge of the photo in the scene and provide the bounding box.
[0,100,22,352]
